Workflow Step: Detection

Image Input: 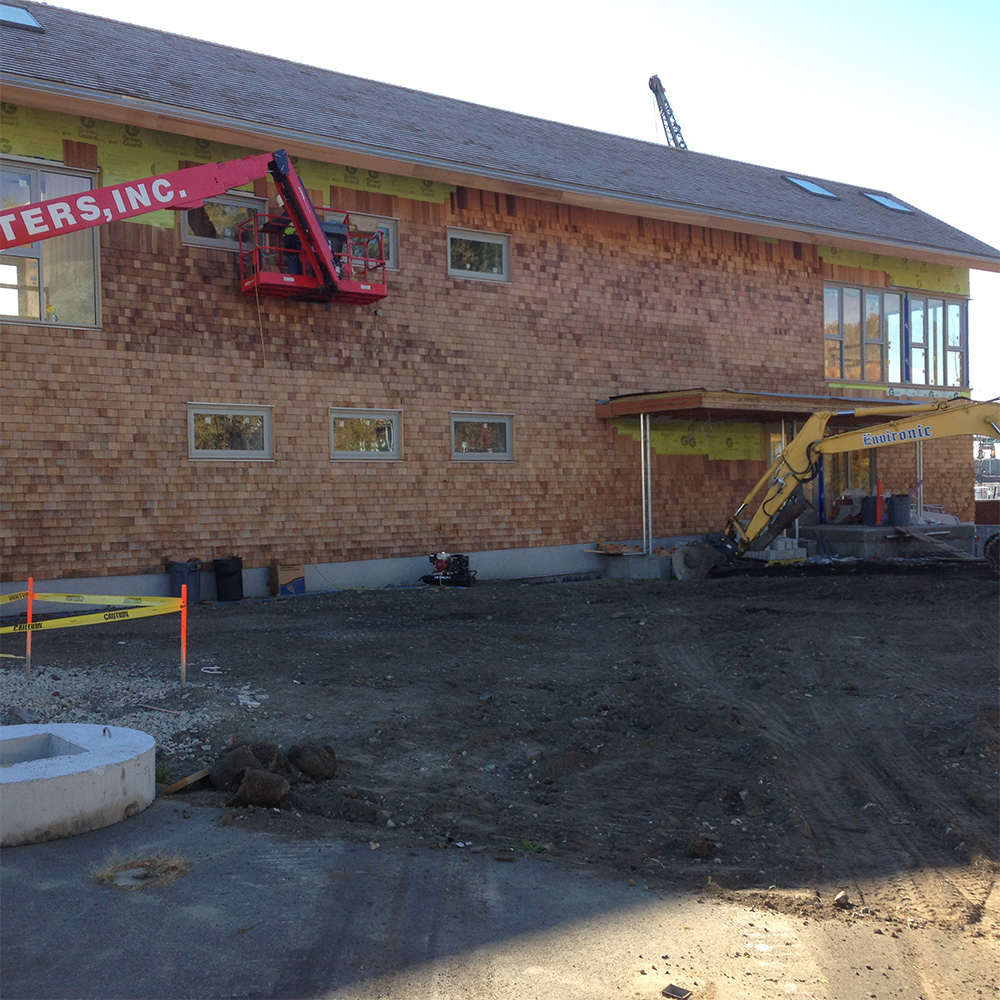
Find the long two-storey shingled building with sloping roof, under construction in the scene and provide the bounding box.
[0,2,1000,593]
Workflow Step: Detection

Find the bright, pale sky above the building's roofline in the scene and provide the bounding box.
[59,0,1000,399]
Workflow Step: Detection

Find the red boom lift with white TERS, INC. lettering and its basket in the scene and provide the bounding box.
[0,150,387,305]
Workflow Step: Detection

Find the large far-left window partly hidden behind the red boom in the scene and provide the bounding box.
[0,160,97,326]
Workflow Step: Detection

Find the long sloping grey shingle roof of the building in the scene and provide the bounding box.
[0,3,1000,270]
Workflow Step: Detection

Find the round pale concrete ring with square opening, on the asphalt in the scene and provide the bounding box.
[0,723,156,847]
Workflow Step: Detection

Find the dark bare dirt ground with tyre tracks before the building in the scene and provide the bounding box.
[3,564,1000,996]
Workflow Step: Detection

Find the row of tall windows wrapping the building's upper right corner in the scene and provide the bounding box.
[823,285,968,388]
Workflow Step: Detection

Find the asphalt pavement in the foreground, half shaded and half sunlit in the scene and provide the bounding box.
[0,798,992,1000]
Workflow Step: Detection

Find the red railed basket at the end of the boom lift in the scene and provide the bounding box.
[239,210,388,305]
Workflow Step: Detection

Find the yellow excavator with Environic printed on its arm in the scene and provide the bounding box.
[672,399,1000,580]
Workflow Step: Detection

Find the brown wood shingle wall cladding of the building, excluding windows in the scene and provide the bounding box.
[2,177,972,580]
